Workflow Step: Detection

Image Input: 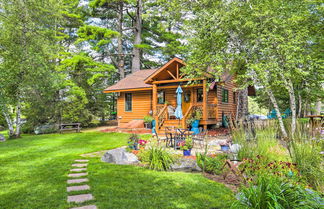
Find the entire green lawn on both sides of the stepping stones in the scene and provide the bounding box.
[0,132,233,209]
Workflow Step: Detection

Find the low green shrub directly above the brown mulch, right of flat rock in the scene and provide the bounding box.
[196,153,227,174]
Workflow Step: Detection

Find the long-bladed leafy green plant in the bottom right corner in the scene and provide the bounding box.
[233,176,323,209]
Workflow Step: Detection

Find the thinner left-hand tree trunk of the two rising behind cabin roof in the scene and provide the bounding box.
[117,1,125,79]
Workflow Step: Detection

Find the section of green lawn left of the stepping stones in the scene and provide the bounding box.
[0,133,128,209]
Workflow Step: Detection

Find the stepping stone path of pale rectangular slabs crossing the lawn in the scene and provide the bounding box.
[66,160,97,209]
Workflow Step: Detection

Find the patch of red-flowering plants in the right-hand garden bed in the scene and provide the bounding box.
[239,155,304,184]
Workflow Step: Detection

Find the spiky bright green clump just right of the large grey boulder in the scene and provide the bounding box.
[139,146,174,171]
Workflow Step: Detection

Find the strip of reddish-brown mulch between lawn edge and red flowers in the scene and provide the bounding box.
[203,173,242,193]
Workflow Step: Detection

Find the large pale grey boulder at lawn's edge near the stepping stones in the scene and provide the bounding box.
[101,148,139,165]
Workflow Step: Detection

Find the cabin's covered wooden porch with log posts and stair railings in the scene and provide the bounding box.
[152,79,219,131]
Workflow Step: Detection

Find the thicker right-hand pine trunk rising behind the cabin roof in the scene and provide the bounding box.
[132,0,143,73]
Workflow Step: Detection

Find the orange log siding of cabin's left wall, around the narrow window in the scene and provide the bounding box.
[117,91,152,123]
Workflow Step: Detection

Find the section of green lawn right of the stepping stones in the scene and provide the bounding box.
[89,159,234,208]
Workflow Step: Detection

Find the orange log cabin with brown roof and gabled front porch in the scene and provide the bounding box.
[104,58,256,132]
